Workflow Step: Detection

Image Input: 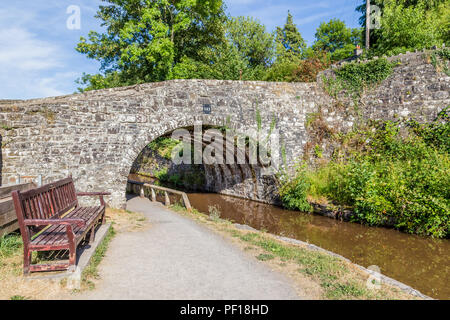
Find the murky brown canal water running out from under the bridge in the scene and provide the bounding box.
[126,176,450,299]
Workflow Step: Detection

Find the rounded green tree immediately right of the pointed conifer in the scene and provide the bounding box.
[313,19,362,61]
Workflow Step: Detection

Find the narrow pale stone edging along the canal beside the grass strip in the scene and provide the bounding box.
[233,223,434,300]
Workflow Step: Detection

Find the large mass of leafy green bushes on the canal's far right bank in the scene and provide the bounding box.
[303,115,450,238]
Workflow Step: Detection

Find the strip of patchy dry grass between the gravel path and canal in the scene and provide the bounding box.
[171,205,416,300]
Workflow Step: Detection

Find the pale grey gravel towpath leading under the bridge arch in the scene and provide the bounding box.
[78,198,304,300]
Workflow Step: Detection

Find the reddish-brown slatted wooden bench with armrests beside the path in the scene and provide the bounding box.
[12,178,110,274]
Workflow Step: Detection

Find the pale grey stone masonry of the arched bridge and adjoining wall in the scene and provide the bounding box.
[0,54,450,207]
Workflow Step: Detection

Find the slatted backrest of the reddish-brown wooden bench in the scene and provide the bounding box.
[13,178,78,224]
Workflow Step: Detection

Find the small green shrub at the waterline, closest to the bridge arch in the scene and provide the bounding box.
[279,165,311,212]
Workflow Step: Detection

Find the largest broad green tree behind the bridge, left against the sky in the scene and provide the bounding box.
[76,0,226,89]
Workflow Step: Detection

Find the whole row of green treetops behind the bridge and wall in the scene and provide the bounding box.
[76,0,450,91]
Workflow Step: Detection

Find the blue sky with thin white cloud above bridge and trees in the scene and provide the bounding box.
[0,0,362,99]
